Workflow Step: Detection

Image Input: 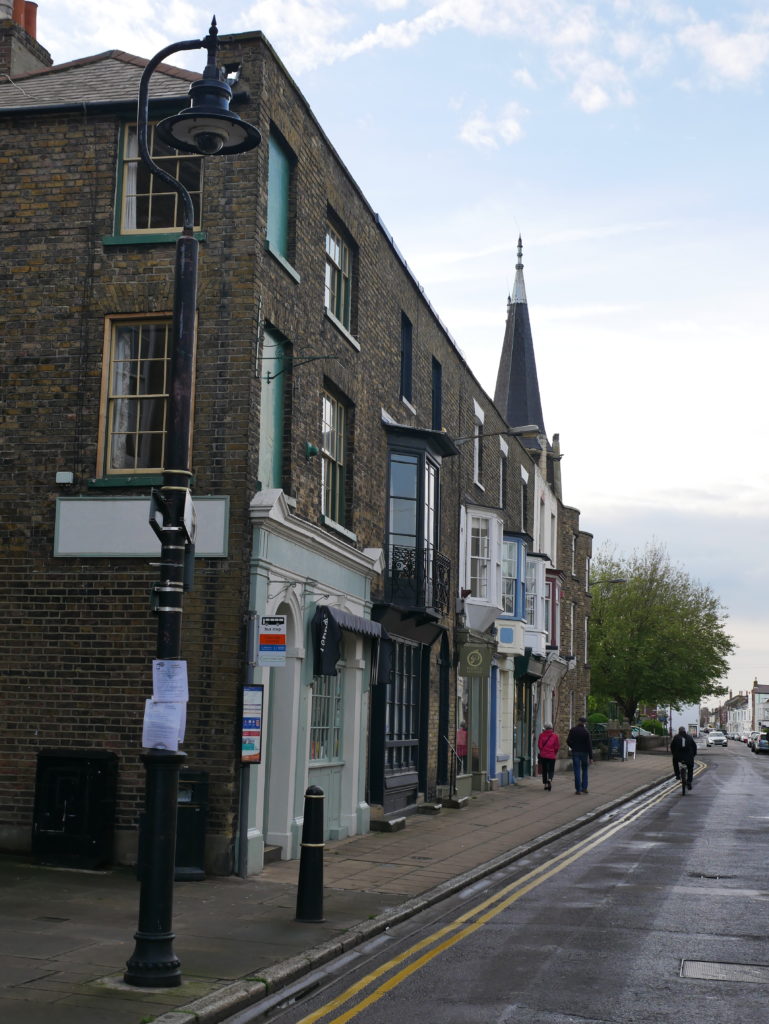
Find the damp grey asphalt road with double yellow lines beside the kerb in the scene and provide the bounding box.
[229,743,769,1024]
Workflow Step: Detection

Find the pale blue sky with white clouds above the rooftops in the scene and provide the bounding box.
[37,0,769,703]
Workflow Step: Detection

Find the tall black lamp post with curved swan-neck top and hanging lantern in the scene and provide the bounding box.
[124,18,261,988]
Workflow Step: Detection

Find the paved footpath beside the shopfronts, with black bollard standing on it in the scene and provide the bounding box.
[0,751,672,1024]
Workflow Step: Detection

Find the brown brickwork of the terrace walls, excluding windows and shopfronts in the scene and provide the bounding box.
[0,33,589,856]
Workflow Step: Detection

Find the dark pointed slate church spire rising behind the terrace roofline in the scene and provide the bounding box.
[494,236,547,434]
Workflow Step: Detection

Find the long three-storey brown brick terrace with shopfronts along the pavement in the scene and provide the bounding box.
[0,6,590,873]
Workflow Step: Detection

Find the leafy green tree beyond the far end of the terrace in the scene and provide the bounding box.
[590,542,734,722]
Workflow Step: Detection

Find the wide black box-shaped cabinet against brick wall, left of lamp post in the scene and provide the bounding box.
[32,750,118,868]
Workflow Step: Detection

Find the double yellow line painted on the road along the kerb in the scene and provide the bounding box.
[297,763,704,1024]
